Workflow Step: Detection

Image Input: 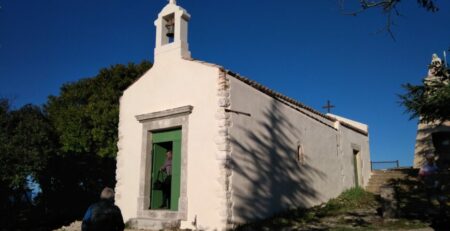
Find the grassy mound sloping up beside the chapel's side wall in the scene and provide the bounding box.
[237,188,428,230]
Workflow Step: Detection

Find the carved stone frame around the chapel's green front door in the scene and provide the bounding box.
[135,105,194,220]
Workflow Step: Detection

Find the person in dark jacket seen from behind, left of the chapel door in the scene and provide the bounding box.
[81,187,125,231]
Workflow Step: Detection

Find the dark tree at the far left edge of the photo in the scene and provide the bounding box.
[0,99,55,229]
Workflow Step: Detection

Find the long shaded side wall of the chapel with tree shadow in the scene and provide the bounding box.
[229,76,370,223]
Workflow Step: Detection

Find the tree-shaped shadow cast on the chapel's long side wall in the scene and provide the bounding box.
[230,99,325,222]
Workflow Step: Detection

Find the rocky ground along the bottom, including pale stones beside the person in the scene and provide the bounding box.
[57,189,450,231]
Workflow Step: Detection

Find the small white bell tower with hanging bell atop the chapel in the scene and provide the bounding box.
[155,0,191,62]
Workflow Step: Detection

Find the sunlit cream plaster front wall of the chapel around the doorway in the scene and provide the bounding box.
[116,57,223,229]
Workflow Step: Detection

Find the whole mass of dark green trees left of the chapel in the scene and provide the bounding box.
[0,61,152,230]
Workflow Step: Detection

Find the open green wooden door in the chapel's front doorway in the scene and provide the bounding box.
[150,129,181,211]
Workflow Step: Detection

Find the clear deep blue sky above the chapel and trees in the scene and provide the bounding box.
[0,0,450,166]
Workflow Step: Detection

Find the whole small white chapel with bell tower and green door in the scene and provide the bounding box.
[115,0,370,230]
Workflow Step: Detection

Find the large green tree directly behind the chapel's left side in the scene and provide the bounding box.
[38,61,152,228]
